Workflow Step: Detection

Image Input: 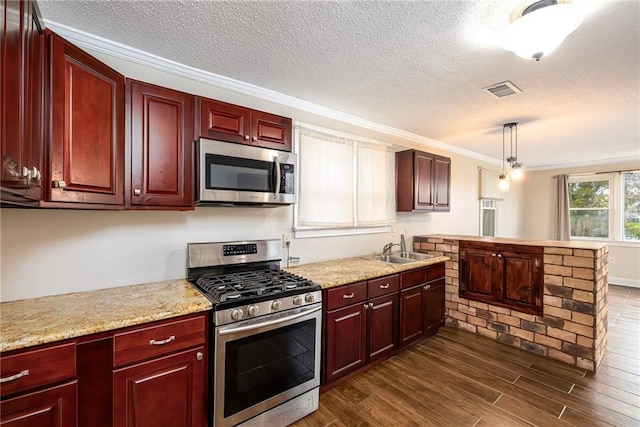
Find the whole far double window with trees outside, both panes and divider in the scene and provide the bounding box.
[568,171,640,241]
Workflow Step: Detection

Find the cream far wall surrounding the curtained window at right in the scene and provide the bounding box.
[521,160,640,287]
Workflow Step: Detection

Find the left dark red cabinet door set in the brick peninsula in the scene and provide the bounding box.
[460,248,502,303]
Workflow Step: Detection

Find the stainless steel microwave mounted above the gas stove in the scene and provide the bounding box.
[195,138,297,206]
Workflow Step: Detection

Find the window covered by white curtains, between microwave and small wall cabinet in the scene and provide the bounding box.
[294,126,395,231]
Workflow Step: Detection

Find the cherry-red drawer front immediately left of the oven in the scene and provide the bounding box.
[113,316,205,366]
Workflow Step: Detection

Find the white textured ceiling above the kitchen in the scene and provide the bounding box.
[38,0,640,171]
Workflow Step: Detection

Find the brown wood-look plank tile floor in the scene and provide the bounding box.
[294,285,640,427]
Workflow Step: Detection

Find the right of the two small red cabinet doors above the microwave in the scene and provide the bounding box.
[251,111,292,151]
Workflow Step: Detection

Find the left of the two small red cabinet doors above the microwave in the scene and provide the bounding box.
[199,98,251,144]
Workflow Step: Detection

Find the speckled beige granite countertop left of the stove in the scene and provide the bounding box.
[0,279,212,352]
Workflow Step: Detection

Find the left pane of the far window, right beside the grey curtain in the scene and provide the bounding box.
[569,178,610,238]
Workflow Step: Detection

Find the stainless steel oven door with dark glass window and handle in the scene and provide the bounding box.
[214,304,322,427]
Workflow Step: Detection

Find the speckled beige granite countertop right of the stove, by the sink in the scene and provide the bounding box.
[285,256,450,289]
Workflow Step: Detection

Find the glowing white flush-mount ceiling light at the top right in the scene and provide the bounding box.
[502,0,584,61]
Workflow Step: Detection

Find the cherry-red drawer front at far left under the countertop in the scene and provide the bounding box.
[0,342,76,396]
